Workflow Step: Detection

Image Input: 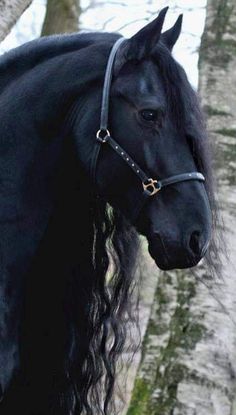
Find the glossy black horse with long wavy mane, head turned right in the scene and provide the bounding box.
[0,9,214,415]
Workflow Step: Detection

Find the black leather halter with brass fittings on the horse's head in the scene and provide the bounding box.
[91,38,205,221]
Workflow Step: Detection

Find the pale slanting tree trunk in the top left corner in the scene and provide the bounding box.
[0,0,32,41]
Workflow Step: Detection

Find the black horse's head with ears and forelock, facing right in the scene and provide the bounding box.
[77,8,212,269]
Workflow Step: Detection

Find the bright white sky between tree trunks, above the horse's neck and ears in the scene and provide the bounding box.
[0,0,206,88]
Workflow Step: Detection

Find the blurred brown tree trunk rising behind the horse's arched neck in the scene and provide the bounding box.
[42,0,81,36]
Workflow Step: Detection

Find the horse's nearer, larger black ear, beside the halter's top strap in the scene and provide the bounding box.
[126,7,168,60]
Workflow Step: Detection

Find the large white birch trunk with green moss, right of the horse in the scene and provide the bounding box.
[126,0,236,415]
